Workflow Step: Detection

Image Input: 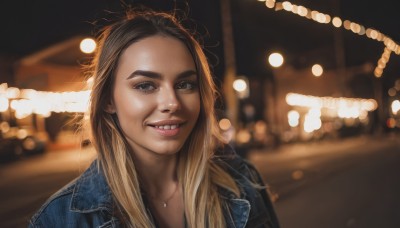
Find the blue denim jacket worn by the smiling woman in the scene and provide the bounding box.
[29,147,279,228]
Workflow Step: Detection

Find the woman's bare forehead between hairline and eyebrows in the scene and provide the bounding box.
[117,35,195,74]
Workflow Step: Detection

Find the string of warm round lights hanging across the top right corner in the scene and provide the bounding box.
[265,0,400,78]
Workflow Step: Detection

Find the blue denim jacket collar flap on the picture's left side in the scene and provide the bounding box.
[70,160,113,213]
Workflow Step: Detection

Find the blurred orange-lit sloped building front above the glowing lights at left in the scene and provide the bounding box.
[15,36,90,92]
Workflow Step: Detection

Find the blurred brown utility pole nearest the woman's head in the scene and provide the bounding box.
[220,0,238,129]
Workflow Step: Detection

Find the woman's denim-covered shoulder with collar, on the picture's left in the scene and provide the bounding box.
[29,160,112,227]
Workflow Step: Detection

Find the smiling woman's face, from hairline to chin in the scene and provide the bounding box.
[108,35,200,160]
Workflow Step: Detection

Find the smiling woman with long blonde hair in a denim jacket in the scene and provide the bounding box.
[30,11,278,228]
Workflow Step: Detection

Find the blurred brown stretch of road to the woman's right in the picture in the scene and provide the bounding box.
[249,135,400,228]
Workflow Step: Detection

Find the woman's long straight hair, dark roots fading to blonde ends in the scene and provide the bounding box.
[90,11,239,228]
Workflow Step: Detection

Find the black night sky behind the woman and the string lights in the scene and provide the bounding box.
[0,0,400,86]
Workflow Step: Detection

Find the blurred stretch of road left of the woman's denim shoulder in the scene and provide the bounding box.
[0,149,95,228]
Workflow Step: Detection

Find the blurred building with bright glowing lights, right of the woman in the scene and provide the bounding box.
[265,64,377,141]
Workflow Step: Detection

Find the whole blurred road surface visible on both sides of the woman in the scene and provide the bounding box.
[0,136,400,228]
